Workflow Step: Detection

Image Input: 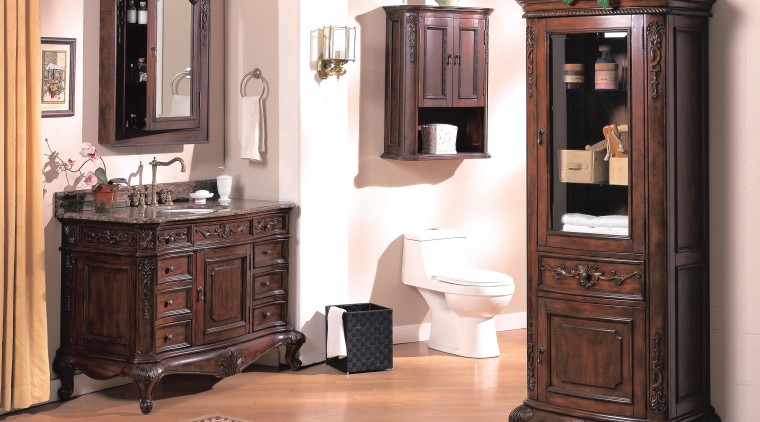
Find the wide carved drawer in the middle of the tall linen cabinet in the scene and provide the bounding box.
[538,256,645,300]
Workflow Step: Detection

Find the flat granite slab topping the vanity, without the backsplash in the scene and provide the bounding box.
[56,199,295,224]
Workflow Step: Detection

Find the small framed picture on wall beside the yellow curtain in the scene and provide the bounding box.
[40,37,77,117]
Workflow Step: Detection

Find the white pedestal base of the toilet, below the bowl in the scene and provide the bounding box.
[428,312,501,358]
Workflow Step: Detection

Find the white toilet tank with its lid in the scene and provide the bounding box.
[401,229,475,284]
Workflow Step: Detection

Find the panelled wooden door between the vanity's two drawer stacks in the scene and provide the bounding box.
[196,245,251,344]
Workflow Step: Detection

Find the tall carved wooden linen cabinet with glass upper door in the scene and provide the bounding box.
[509,0,719,422]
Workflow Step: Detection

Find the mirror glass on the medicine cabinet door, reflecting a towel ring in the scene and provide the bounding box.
[155,0,193,119]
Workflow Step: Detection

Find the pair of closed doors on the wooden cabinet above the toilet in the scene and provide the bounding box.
[420,17,486,107]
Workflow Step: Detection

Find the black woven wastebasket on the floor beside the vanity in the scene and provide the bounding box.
[325,303,393,374]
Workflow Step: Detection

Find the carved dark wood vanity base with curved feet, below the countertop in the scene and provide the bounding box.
[53,205,305,413]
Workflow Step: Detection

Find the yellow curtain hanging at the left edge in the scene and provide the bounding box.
[0,0,50,410]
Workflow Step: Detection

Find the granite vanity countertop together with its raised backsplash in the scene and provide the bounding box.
[53,180,296,224]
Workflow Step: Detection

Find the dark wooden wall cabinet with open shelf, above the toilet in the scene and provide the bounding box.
[382,6,493,160]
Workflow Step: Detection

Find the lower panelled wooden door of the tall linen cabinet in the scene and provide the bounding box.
[538,298,646,417]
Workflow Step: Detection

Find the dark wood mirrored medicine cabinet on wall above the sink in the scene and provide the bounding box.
[98,0,211,146]
